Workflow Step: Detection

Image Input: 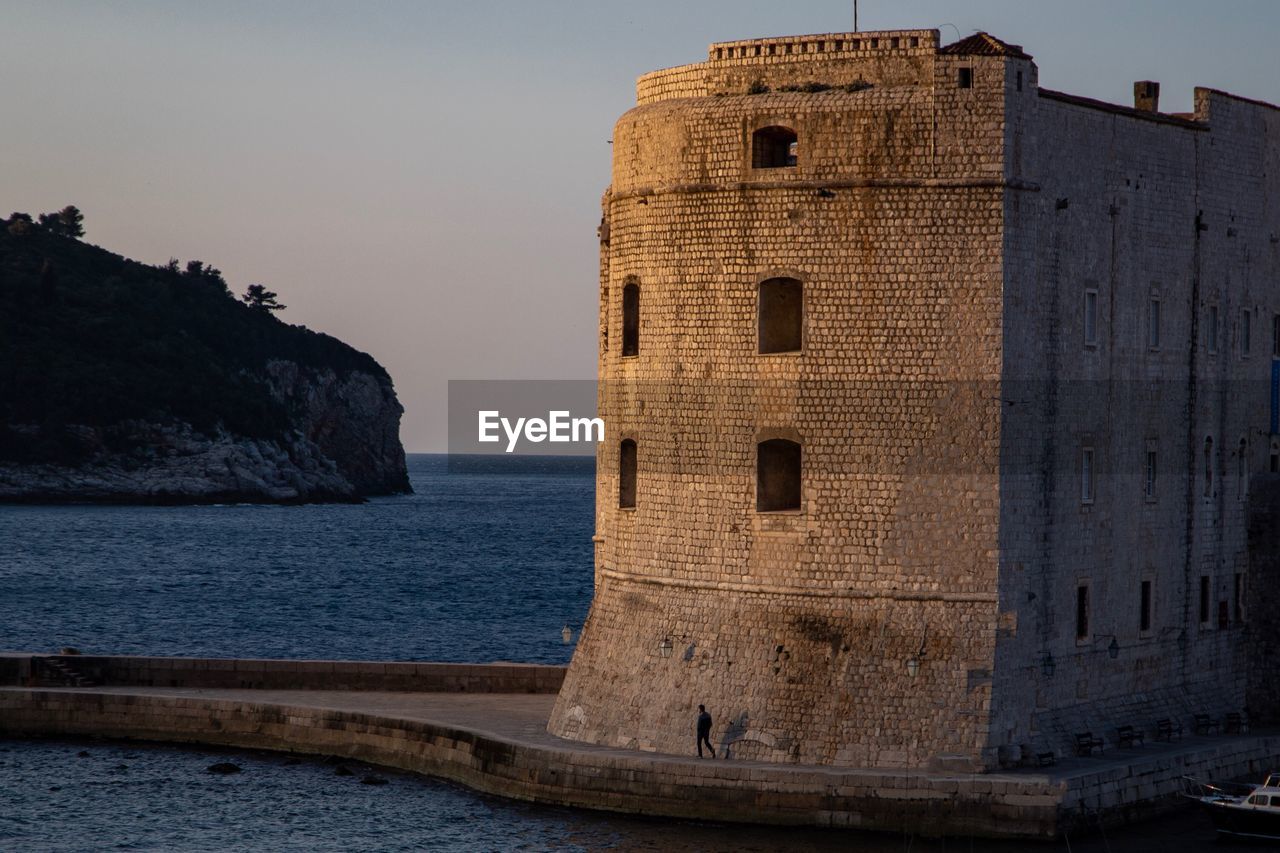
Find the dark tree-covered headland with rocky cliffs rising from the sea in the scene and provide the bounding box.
[0,214,410,503]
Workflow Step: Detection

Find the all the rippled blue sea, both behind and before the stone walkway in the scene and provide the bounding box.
[0,455,1228,853]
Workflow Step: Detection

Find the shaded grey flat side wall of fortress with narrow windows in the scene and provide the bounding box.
[992,81,1280,760]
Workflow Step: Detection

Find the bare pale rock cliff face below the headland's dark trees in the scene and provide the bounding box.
[0,361,411,503]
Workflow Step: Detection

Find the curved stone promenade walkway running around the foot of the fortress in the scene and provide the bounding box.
[0,686,1280,838]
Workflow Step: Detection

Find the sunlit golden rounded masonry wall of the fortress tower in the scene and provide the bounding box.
[549,33,1005,766]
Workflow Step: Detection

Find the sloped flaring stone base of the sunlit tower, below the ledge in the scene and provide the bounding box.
[548,571,996,771]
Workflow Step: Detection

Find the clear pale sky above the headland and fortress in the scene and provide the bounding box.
[0,0,1280,451]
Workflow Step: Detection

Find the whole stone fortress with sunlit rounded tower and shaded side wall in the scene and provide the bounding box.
[549,29,1280,770]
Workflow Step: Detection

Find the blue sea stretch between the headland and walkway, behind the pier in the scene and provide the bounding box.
[0,455,595,663]
